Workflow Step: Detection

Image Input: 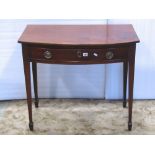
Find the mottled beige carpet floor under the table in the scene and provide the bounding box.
[0,99,155,135]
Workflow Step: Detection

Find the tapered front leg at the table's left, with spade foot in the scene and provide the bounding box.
[24,61,33,131]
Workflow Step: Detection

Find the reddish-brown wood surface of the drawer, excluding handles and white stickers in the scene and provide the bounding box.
[28,45,128,64]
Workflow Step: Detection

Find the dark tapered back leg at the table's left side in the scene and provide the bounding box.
[32,62,39,108]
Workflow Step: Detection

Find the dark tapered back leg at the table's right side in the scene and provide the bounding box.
[123,61,128,108]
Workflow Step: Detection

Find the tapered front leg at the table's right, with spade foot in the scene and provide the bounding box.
[128,46,136,131]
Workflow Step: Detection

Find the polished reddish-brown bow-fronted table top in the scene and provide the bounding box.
[18,25,139,45]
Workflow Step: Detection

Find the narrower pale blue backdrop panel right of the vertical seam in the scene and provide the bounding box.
[105,19,155,99]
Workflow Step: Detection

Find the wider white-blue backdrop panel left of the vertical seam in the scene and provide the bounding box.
[0,20,107,100]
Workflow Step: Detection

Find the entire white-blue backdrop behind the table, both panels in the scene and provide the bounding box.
[0,19,155,100]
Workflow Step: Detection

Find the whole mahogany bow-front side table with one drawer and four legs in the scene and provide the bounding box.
[18,25,139,131]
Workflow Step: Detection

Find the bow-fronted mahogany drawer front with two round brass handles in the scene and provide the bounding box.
[30,47,128,63]
